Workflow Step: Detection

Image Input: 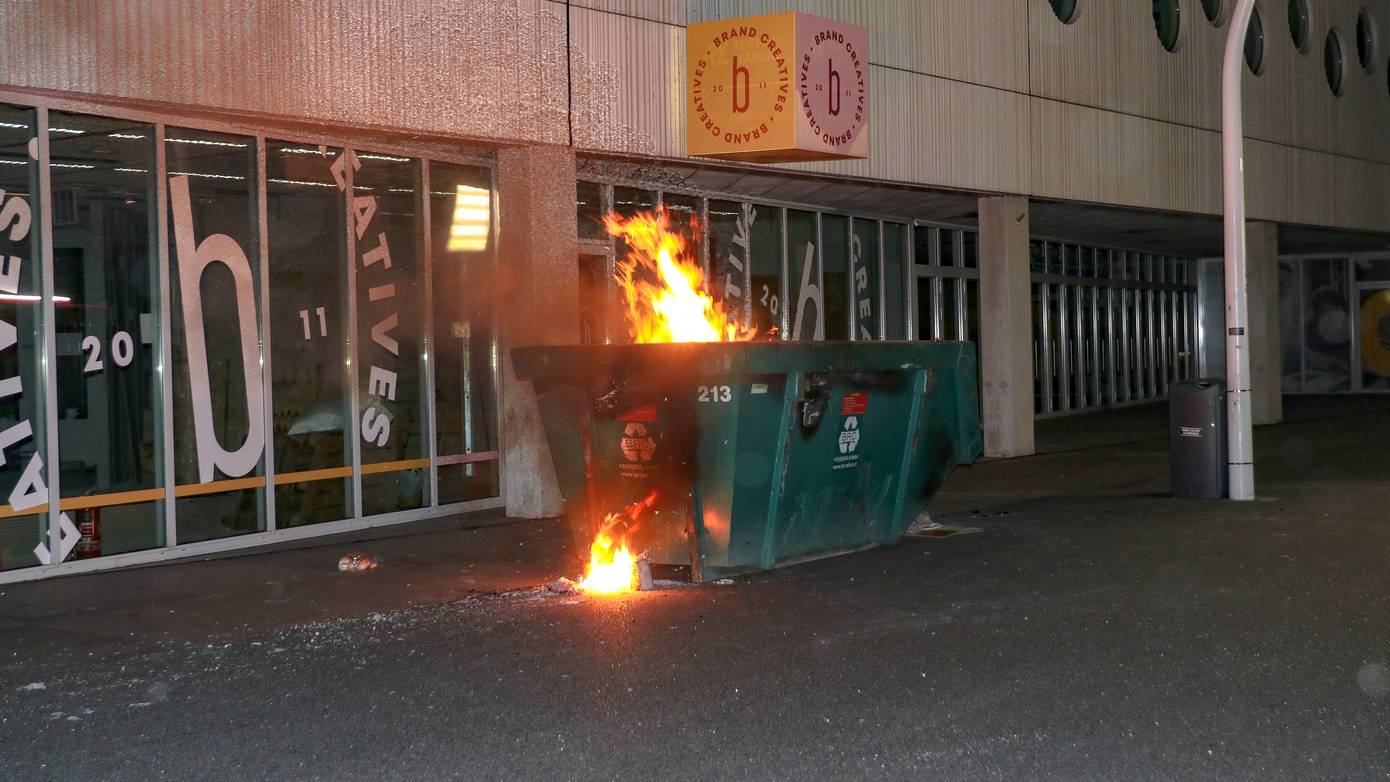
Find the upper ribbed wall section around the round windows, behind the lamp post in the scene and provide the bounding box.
[1029,0,1390,163]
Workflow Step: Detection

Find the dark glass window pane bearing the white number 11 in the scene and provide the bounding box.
[265,142,352,528]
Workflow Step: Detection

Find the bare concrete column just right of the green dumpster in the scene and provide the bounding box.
[979,196,1034,457]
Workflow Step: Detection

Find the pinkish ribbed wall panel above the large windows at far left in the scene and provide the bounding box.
[0,0,569,143]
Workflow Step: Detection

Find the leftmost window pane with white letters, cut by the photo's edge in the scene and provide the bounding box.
[0,104,47,569]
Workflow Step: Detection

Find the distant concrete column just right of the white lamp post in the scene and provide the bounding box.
[1245,222,1284,426]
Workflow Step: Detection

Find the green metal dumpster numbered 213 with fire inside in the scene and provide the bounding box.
[512,342,981,581]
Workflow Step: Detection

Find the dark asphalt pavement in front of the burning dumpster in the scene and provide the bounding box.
[0,400,1390,781]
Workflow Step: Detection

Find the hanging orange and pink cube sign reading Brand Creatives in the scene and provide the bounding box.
[685,11,869,163]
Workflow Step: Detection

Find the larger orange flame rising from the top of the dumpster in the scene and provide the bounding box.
[603,207,758,343]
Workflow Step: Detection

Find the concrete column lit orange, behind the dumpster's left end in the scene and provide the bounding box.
[498,146,580,518]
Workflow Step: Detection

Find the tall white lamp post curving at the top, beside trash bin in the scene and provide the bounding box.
[1222,0,1255,500]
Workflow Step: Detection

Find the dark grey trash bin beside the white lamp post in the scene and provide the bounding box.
[1168,378,1227,499]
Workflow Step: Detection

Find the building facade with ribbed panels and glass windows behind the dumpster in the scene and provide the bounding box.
[0,0,1390,582]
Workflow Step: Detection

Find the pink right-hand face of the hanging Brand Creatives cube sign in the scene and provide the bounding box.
[795,14,869,157]
